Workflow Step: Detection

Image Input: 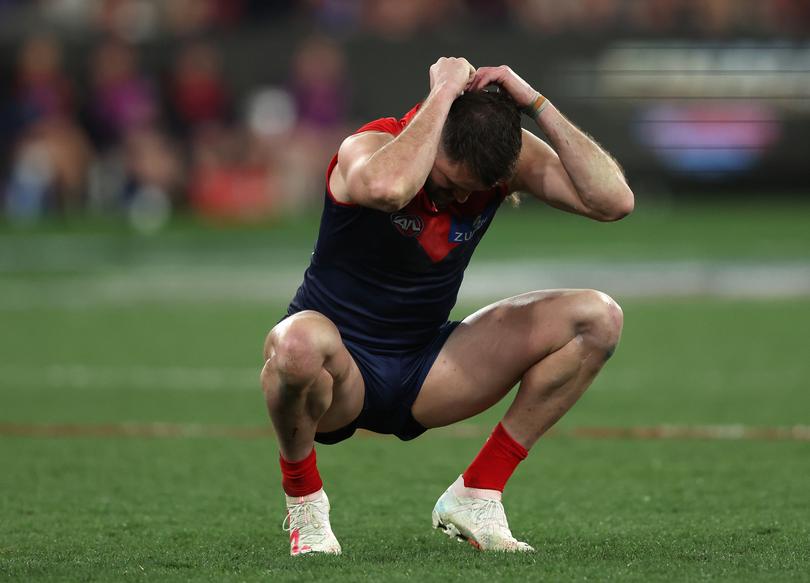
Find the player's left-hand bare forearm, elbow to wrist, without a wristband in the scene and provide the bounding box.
[365,86,456,208]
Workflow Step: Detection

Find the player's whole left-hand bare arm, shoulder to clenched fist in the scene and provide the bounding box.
[330,57,475,212]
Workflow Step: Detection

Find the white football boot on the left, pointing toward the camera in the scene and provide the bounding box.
[281,488,340,557]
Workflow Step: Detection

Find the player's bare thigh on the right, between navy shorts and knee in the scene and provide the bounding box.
[412,290,582,427]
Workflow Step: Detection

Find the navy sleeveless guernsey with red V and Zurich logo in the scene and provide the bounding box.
[287,105,508,353]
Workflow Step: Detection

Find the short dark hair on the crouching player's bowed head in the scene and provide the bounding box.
[442,90,522,187]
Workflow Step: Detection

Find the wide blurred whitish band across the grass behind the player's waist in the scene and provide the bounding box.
[0,260,810,310]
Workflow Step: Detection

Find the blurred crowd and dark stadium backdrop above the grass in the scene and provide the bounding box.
[0,0,810,230]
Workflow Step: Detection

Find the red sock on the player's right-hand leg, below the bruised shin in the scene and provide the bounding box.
[463,423,529,492]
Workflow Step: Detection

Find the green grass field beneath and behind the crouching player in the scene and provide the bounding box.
[0,205,810,582]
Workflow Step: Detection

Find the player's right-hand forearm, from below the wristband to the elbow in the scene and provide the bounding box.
[535,103,633,215]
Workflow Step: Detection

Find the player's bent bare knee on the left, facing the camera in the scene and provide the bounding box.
[262,312,340,386]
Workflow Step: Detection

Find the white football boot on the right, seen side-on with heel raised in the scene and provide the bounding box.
[433,476,534,552]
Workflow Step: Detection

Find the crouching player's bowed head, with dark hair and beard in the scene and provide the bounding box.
[426,86,521,204]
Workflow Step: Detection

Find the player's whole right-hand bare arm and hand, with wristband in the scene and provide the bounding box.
[470,66,634,221]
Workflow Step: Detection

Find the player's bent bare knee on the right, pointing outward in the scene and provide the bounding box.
[573,290,624,357]
